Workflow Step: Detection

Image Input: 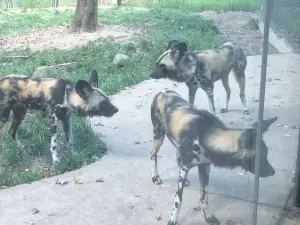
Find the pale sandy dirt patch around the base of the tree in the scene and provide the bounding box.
[0,24,140,51]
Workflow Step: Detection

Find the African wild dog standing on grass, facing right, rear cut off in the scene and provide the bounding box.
[0,70,118,162]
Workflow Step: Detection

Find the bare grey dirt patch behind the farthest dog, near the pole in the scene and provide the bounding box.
[199,11,277,55]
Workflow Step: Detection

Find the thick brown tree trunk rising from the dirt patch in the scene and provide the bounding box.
[69,0,98,33]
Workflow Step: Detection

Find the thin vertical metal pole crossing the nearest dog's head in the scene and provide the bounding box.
[252,0,273,225]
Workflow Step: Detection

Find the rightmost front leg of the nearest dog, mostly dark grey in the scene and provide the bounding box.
[196,163,220,225]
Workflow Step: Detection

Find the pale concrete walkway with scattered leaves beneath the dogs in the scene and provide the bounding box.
[0,54,300,225]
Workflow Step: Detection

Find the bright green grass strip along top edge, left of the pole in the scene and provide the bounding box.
[122,0,259,11]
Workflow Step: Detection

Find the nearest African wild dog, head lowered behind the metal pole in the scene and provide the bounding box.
[151,90,277,225]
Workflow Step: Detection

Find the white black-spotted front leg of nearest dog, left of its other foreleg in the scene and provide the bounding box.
[168,164,190,225]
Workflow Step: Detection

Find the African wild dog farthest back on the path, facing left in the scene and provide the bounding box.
[150,40,249,114]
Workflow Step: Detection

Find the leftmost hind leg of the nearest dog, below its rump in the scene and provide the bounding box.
[151,125,165,185]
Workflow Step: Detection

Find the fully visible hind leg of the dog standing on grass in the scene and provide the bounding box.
[9,107,26,148]
